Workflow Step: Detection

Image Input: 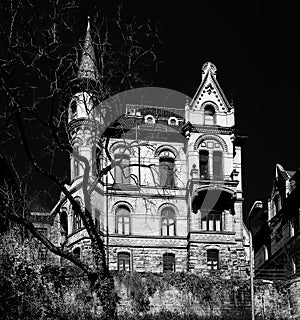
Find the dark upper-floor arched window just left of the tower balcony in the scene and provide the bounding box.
[159,150,175,188]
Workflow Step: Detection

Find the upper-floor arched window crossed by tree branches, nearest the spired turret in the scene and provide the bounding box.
[114,148,130,184]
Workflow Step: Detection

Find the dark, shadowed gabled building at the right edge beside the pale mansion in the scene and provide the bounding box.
[249,164,300,280]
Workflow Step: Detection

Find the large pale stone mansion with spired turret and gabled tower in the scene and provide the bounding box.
[51,20,249,276]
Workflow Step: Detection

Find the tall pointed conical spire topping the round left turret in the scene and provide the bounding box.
[78,17,98,81]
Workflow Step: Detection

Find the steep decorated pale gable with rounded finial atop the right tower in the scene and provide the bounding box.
[191,62,233,112]
